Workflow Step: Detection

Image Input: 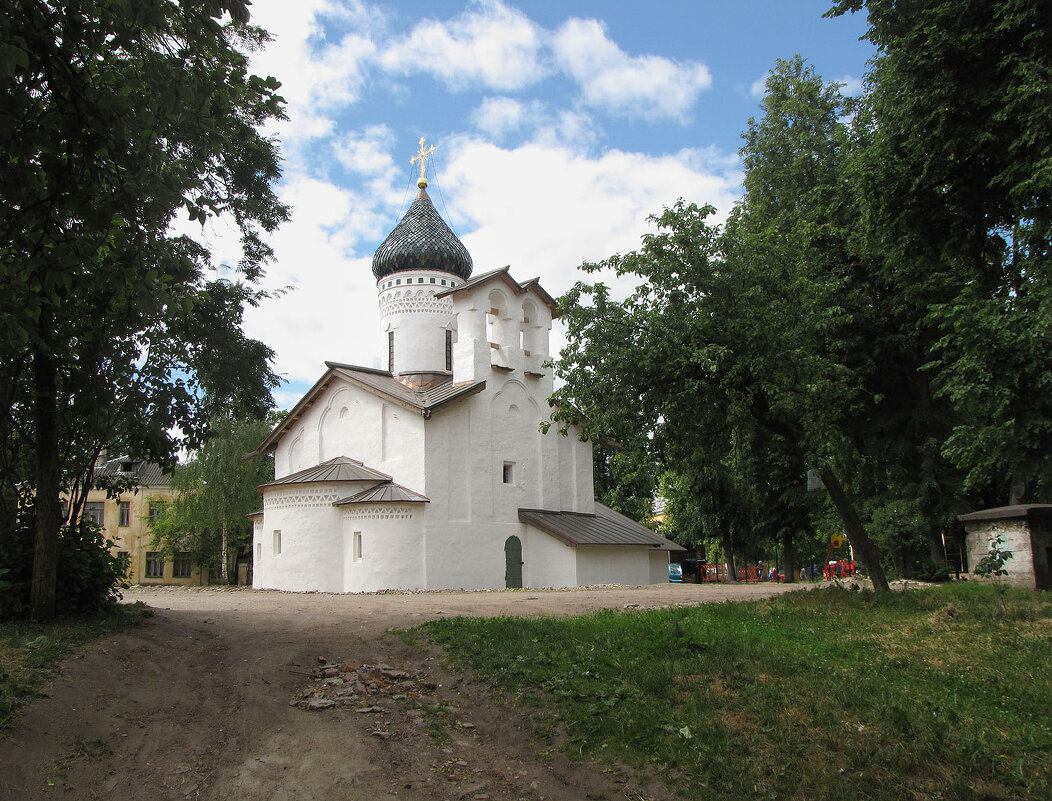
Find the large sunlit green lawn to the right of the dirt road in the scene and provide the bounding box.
[423,583,1052,799]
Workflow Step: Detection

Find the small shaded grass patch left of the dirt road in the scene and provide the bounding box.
[0,604,153,730]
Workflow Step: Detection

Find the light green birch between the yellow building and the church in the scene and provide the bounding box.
[149,416,274,583]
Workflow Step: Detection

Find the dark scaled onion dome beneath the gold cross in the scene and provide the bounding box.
[372,186,471,281]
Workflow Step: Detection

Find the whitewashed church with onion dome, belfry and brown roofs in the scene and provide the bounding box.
[252,158,683,593]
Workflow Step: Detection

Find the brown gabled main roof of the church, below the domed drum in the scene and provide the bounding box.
[250,362,486,459]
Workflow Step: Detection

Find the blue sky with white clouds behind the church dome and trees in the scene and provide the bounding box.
[200,0,873,408]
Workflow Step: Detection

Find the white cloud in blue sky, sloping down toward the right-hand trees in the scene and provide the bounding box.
[553,18,712,120]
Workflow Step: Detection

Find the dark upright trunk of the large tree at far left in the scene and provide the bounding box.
[29,336,62,621]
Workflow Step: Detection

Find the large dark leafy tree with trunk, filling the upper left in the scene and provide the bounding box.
[0,0,287,619]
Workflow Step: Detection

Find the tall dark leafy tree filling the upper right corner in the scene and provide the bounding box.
[830,0,1052,504]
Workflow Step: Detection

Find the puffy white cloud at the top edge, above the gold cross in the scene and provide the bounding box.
[380,0,544,91]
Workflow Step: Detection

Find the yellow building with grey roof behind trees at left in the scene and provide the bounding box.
[84,458,208,585]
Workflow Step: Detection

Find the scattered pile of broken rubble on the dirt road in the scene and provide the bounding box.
[289,657,438,715]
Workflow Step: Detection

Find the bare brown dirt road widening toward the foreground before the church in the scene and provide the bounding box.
[0,584,791,801]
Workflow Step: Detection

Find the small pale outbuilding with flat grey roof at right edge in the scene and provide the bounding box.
[957,503,1052,589]
